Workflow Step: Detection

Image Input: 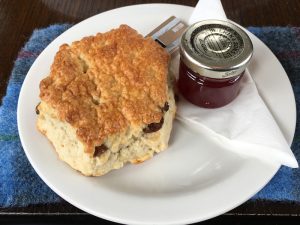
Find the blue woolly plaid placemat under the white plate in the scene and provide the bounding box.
[0,24,300,207]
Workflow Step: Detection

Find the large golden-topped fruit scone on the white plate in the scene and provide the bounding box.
[36,25,176,176]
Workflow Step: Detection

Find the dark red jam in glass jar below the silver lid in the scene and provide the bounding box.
[177,60,244,108]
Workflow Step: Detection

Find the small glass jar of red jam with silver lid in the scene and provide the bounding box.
[177,20,253,108]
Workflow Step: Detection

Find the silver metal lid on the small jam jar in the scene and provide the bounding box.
[180,20,253,79]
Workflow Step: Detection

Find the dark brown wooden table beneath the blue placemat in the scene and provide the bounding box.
[0,0,300,224]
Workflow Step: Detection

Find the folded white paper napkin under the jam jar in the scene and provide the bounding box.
[177,0,298,168]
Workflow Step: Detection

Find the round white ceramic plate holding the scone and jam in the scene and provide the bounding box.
[18,4,296,224]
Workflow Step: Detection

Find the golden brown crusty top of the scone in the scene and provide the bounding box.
[40,25,169,153]
